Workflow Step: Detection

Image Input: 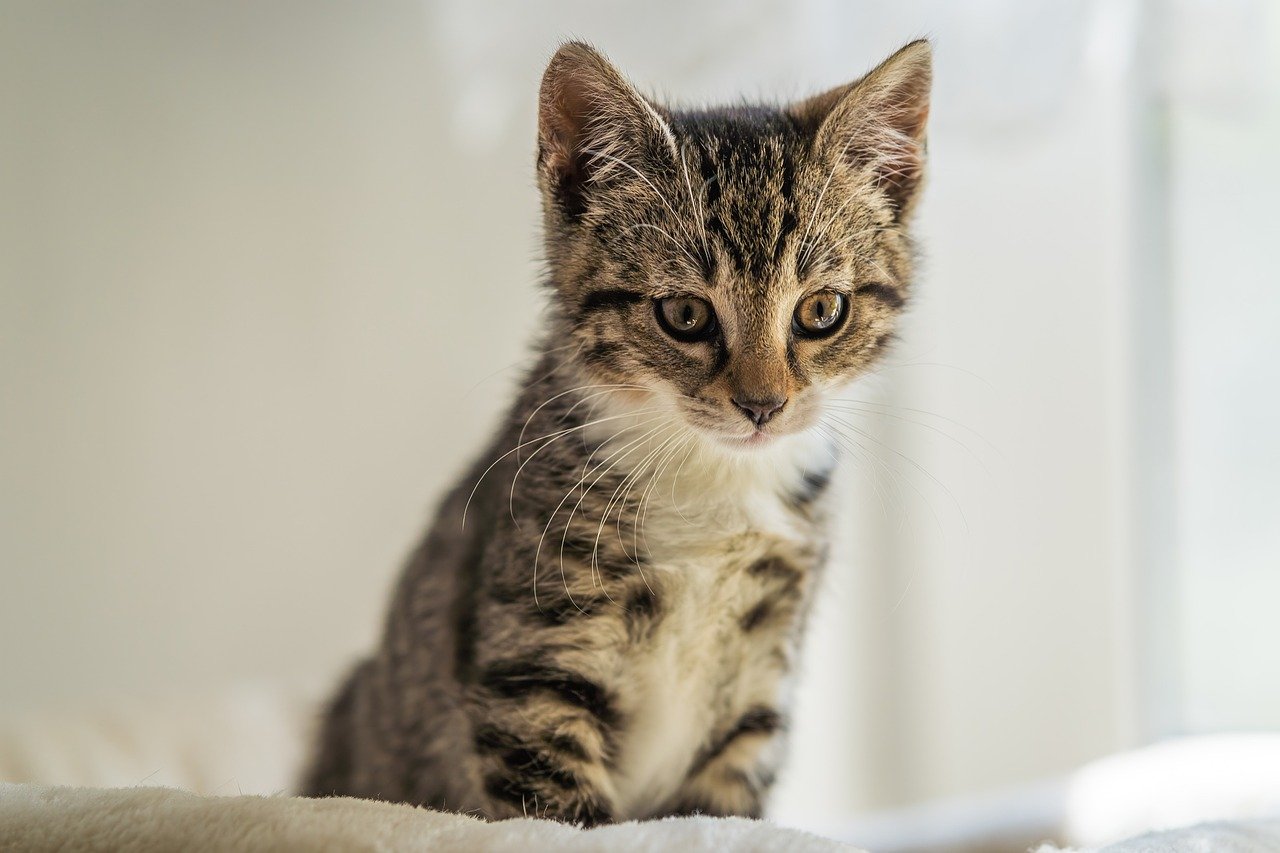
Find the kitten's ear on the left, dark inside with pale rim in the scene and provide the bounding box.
[538,41,676,218]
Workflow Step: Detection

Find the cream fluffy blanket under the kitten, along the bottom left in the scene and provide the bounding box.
[0,784,856,853]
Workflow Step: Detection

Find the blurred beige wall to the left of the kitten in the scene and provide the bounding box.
[0,4,536,703]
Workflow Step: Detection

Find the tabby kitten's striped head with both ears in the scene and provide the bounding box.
[538,41,931,447]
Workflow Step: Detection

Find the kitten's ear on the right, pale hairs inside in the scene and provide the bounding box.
[791,40,933,220]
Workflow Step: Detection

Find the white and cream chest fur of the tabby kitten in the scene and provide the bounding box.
[614,435,832,817]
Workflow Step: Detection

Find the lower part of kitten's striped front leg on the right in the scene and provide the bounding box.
[660,706,783,817]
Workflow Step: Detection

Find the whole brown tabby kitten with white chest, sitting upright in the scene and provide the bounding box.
[305,41,931,824]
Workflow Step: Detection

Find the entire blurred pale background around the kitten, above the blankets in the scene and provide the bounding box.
[0,0,1280,845]
